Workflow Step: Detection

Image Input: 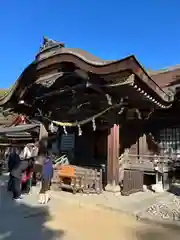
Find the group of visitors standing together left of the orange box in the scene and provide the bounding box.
[6,144,53,204]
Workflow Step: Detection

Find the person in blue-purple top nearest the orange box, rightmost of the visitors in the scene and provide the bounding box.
[39,156,53,204]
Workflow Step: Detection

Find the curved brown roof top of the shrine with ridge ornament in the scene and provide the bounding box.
[0,38,177,105]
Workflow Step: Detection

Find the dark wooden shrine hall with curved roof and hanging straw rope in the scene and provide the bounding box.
[0,38,180,194]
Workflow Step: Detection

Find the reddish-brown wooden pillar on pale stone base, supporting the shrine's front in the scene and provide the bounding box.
[106,124,120,192]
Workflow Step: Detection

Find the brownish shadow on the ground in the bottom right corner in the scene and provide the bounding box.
[136,220,180,240]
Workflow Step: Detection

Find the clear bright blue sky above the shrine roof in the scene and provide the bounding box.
[0,0,180,88]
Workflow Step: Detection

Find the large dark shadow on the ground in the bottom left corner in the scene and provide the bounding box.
[0,174,65,240]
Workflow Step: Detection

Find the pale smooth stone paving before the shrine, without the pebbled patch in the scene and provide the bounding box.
[52,186,169,217]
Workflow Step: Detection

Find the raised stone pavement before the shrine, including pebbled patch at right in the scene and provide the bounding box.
[52,186,180,226]
